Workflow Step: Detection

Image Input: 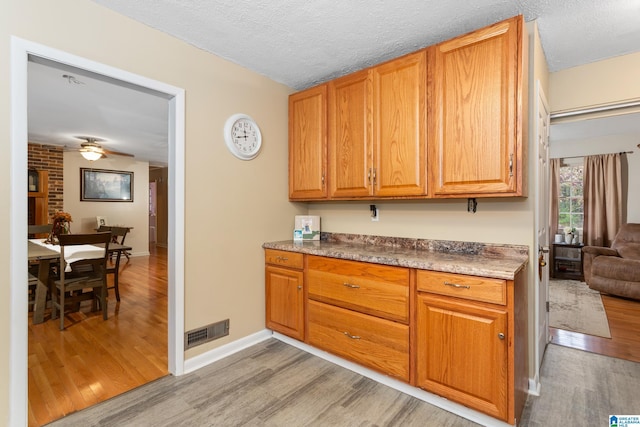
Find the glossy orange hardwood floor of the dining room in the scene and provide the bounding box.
[28,247,168,426]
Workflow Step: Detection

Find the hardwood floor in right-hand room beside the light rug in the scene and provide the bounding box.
[549,295,640,362]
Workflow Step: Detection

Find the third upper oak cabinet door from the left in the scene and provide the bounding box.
[373,51,427,197]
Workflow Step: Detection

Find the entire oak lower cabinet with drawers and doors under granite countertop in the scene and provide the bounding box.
[266,250,528,424]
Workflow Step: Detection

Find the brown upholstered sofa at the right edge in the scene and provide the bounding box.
[582,224,640,300]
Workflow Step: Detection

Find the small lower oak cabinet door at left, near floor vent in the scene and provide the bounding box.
[265,265,304,340]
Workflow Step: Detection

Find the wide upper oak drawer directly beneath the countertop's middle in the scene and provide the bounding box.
[306,256,409,323]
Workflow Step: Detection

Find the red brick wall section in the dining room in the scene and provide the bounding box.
[25,143,64,216]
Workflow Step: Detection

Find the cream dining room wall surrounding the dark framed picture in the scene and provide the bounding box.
[64,152,149,256]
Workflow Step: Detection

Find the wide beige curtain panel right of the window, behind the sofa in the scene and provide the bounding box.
[583,154,622,247]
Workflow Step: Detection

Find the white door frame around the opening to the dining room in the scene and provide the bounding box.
[8,36,185,425]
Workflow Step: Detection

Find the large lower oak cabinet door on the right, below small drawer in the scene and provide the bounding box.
[416,293,508,420]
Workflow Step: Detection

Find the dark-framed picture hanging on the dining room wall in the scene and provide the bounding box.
[80,168,133,202]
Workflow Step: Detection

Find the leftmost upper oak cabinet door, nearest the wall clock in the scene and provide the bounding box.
[289,85,327,200]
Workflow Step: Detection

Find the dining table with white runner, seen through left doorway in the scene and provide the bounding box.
[27,239,133,324]
